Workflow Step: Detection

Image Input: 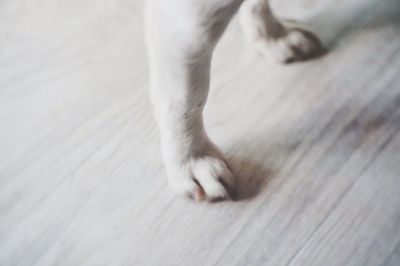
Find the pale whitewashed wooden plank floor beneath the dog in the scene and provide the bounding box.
[0,0,400,266]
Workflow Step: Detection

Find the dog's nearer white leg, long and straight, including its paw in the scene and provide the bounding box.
[147,0,240,200]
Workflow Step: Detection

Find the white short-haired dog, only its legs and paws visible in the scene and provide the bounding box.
[146,0,322,201]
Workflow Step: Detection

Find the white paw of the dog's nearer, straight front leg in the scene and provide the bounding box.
[167,155,234,201]
